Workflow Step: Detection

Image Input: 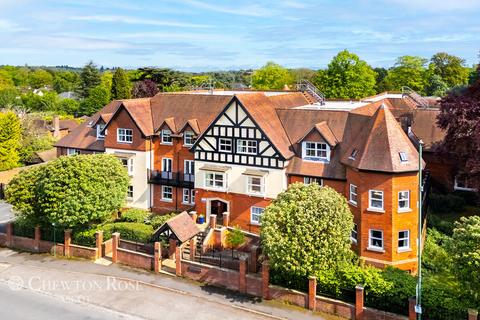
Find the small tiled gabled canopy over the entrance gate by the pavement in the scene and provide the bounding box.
[153,211,200,243]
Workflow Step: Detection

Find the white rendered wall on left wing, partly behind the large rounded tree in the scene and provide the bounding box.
[105,148,152,210]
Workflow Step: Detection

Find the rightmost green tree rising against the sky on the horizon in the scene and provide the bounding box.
[431,52,469,88]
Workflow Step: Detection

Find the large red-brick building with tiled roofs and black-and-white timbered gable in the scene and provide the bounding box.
[56,91,442,272]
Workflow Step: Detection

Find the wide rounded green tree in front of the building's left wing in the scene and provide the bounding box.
[5,154,130,228]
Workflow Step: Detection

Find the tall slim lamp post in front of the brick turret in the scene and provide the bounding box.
[415,139,423,320]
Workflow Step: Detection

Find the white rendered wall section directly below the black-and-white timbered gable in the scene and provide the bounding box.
[195,160,287,198]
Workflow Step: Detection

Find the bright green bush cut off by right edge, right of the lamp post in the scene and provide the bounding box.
[448,216,480,298]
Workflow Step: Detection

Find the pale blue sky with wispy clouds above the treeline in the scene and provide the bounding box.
[0,0,480,71]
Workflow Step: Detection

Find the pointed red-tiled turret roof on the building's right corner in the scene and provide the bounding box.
[341,104,424,173]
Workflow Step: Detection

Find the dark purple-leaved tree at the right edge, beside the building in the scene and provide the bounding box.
[437,67,480,191]
